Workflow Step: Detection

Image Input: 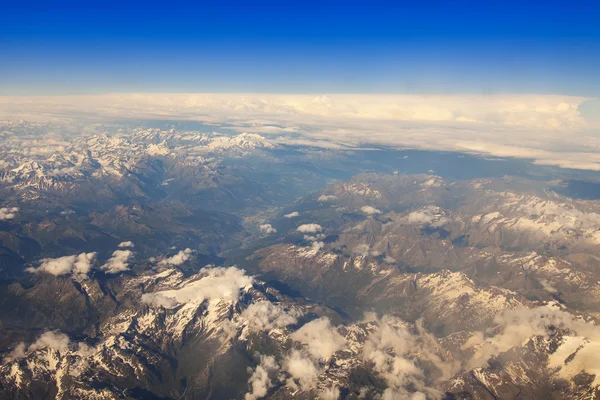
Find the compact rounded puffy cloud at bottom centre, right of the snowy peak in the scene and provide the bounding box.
[291,317,346,359]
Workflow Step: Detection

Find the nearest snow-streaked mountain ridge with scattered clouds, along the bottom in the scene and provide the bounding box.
[0,267,600,399]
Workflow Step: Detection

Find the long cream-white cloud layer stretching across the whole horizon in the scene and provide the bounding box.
[0,93,600,170]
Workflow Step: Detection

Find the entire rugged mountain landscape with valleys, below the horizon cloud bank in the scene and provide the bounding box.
[0,121,600,400]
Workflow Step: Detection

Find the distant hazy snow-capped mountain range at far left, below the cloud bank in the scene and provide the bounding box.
[0,124,276,206]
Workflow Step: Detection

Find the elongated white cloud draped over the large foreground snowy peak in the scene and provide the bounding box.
[142,267,253,308]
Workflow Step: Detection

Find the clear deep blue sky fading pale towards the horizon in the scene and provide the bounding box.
[0,1,600,97]
